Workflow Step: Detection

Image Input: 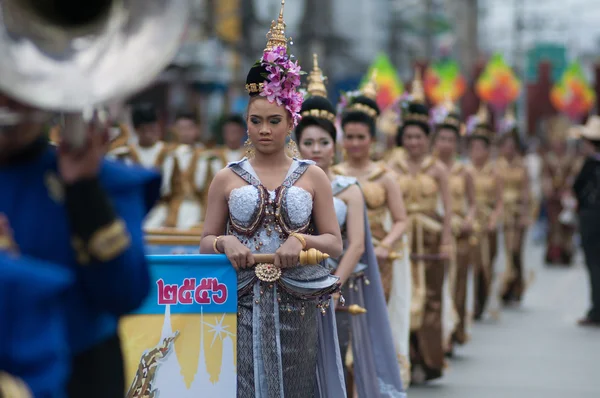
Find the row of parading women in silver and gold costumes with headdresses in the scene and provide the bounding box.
[118,3,530,397]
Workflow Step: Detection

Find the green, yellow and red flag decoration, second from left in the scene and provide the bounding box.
[424,60,467,105]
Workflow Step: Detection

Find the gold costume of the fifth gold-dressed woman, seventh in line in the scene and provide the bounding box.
[498,158,529,301]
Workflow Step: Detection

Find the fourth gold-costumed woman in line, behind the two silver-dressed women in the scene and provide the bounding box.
[466,103,503,319]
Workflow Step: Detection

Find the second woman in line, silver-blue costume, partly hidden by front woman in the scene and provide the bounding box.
[296,55,405,398]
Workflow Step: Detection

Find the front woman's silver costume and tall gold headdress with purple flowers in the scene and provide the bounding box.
[224,3,346,398]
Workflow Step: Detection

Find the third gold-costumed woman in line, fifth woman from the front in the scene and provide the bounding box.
[432,101,477,352]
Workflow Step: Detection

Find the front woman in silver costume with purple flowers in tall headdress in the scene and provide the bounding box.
[200,4,346,398]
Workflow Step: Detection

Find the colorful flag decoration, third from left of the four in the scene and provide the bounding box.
[475,54,521,112]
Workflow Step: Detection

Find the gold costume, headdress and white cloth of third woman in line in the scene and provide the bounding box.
[333,82,411,386]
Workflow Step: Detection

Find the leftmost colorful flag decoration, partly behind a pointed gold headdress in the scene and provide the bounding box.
[360,53,404,110]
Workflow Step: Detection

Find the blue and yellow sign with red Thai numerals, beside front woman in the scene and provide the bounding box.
[120,255,237,398]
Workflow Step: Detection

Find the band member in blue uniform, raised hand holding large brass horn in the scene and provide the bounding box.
[0,91,160,398]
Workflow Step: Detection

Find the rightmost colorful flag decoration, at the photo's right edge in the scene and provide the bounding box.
[550,62,596,121]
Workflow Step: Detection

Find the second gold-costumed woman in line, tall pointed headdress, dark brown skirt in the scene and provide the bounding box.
[388,71,452,383]
